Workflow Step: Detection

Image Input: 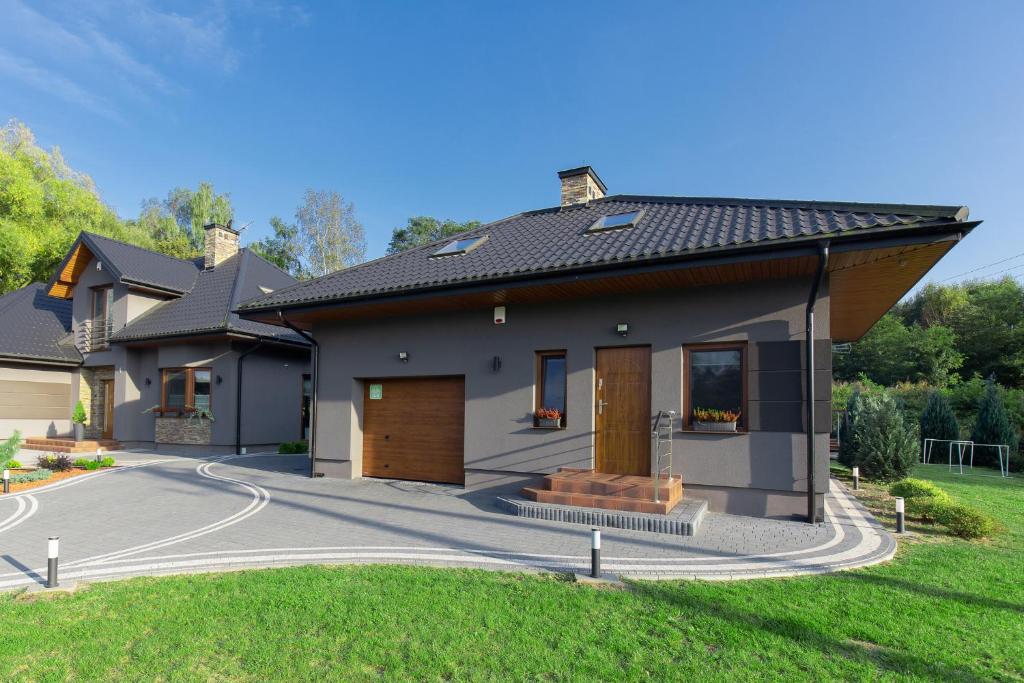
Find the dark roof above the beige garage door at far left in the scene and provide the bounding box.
[0,283,82,364]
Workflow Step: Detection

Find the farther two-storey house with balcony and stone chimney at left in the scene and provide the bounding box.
[0,224,309,450]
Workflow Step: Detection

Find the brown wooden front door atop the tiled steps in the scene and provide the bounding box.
[594,346,650,475]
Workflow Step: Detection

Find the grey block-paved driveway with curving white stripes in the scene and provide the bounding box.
[0,453,895,589]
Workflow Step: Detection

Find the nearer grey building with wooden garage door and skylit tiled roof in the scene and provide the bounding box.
[240,167,978,521]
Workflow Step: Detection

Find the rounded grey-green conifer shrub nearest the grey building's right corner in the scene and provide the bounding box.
[850,394,918,481]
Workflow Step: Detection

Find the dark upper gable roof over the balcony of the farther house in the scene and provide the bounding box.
[72,232,203,294]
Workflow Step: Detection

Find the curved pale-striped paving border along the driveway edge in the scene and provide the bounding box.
[0,462,896,589]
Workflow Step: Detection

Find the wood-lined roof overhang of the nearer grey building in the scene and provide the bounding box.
[237,221,981,341]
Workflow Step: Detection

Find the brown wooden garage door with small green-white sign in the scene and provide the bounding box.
[362,377,466,483]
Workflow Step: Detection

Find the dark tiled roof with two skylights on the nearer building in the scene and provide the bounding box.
[241,195,968,311]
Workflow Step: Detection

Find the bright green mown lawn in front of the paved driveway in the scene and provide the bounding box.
[0,466,1024,681]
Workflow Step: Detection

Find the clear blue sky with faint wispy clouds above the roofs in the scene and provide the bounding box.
[0,0,1024,280]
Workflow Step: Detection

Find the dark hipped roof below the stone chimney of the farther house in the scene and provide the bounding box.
[111,249,307,345]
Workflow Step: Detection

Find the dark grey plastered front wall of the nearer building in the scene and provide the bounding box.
[313,278,830,515]
